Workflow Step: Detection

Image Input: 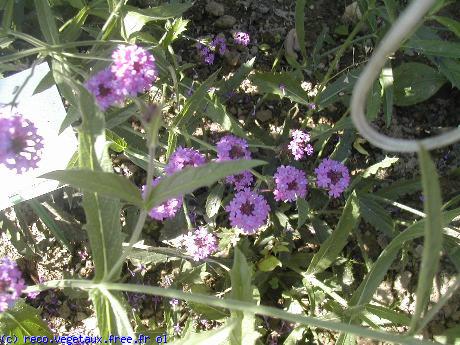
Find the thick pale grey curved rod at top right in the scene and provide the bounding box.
[351,0,460,152]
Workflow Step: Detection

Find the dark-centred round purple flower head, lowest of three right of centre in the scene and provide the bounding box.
[225,188,270,235]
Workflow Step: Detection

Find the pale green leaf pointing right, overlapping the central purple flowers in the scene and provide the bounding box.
[145,159,265,209]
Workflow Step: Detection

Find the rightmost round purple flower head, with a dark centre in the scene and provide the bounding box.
[315,158,350,198]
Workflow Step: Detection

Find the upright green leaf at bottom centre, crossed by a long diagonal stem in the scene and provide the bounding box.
[228,247,260,345]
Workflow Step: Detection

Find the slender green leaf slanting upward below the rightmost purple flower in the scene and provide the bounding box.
[307,192,359,274]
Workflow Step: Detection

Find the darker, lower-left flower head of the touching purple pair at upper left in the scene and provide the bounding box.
[85,69,123,111]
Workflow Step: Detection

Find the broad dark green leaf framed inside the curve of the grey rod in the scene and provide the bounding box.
[394,62,447,106]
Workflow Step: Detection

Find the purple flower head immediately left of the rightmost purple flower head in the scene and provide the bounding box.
[273,165,307,201]
